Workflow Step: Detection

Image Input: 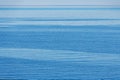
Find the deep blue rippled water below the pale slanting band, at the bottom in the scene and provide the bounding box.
[0,57,120,80]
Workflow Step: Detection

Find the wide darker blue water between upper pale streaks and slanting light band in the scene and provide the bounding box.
[0,25,120,54]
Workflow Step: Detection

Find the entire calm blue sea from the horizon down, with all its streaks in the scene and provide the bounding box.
[0,6,120,80]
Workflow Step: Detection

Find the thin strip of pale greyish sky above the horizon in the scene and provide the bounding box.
[0,0,120,5]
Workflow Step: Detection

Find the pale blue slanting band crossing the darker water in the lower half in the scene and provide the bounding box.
[0,48,119,62]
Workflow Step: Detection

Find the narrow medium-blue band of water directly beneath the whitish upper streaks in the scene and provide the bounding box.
[0,25,120,33]
